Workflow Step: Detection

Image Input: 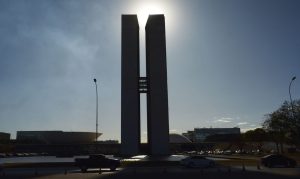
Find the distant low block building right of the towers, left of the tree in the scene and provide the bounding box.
[182,127,241,142]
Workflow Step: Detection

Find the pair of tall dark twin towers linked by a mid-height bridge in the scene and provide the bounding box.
[121,15,169,155]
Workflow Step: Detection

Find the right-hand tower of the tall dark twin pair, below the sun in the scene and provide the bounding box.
[146,15,169,155]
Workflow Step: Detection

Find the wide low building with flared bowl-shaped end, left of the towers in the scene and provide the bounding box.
[17,131,101,144]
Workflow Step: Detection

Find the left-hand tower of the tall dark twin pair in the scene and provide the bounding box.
[121,15,140,155]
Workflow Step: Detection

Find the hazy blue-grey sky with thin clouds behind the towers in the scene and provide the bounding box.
[0,0,300,142]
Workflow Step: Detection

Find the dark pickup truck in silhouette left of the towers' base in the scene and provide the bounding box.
[75,154,121,172]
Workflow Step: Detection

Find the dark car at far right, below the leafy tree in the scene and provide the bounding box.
[261,154,297,168]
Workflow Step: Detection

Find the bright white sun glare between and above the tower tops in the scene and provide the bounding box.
[137,4,164,29]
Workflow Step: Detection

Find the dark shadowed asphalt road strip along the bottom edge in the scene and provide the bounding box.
[0,166,300,179]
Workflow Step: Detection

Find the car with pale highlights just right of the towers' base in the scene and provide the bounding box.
[180,156,215,168]
